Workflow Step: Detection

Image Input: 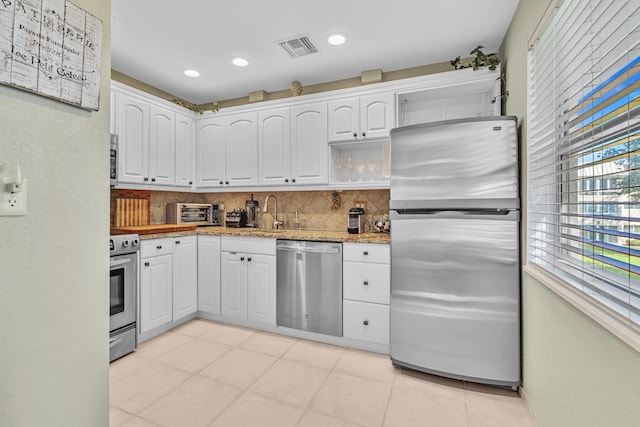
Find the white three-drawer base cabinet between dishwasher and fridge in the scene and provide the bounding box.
[342,243,391,345]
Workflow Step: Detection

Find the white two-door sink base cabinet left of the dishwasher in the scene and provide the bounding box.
[220,237,276,325]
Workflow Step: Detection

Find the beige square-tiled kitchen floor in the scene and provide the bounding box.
[110,320,536,427]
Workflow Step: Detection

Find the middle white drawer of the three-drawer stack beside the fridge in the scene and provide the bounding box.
[342,261,391,304]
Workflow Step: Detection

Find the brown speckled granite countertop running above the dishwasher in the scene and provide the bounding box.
[140,227,389,244]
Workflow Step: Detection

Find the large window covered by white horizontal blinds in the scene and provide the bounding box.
[527,0,640,326]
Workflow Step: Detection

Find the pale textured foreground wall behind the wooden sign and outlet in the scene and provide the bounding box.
[0,0,111,427]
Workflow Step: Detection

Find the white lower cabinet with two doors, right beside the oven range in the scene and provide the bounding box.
[138,236,198,338]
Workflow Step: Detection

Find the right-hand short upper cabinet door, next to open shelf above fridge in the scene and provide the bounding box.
[360,92,394,139]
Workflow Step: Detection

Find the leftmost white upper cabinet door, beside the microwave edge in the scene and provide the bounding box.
[116,93,149,184]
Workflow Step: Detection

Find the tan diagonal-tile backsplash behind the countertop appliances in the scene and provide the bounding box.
[111,189,389,231]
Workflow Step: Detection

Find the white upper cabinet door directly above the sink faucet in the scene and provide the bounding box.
[258,108,291,185]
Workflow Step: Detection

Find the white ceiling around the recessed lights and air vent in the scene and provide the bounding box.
[111,0,518,104]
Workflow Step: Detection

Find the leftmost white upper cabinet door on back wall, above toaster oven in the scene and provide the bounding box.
[196,117,226,188]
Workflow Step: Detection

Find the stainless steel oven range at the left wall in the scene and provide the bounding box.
[109,234,140,362]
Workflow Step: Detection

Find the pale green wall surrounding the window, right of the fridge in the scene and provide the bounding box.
[501,0,640,427]
